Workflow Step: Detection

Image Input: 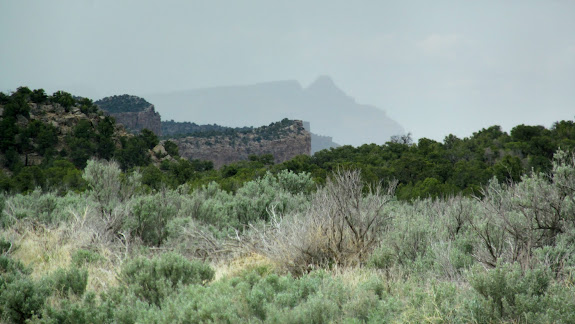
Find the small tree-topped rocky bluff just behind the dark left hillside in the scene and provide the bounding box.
[94,95,162,136]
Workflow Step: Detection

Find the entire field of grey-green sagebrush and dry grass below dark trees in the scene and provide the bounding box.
[0,152,575,323]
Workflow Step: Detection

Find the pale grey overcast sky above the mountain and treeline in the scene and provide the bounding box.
[0,0,575,141]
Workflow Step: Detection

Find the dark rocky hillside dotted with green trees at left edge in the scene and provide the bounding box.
[0,87,177,192]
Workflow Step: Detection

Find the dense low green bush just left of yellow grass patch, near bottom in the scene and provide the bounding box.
[120,253,214,305]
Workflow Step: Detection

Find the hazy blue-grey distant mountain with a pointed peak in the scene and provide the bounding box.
[146,76,405,146]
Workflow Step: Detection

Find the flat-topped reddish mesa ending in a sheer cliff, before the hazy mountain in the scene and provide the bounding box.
[171,120,311,168]
